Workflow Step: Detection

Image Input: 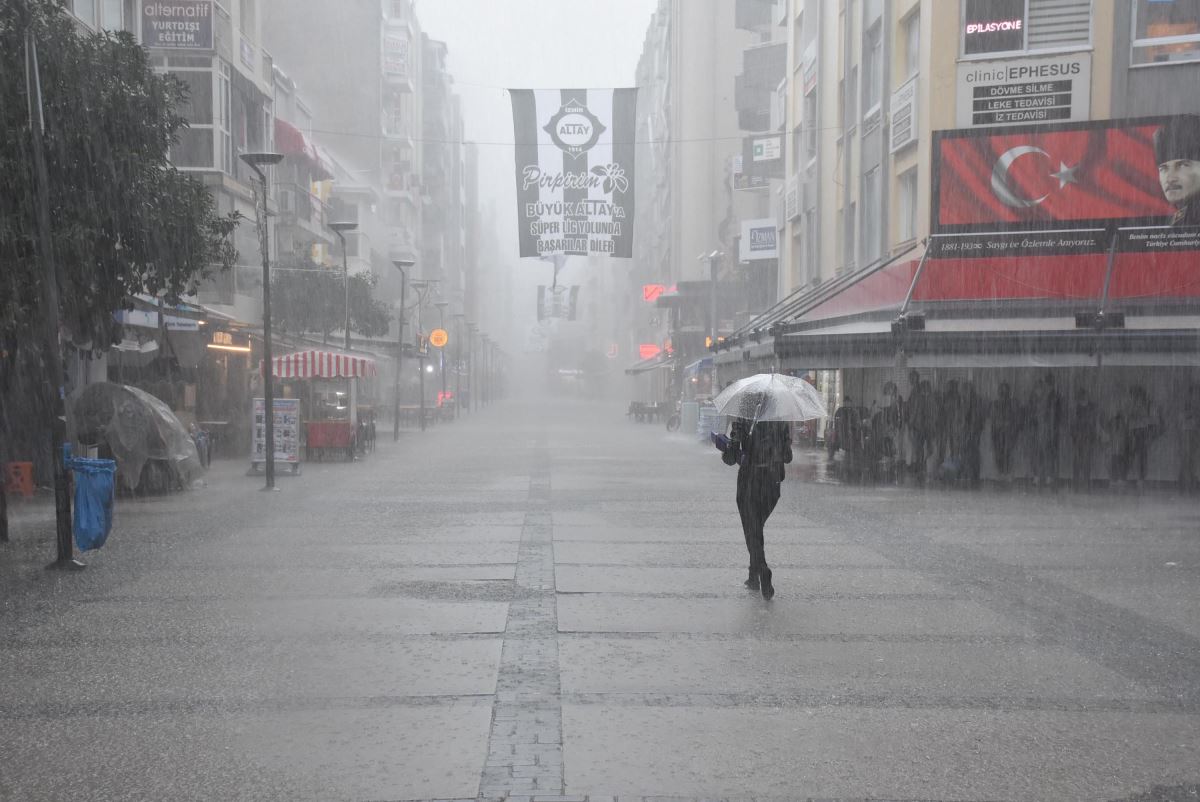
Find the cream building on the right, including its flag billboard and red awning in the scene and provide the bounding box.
[716,0,1200,480]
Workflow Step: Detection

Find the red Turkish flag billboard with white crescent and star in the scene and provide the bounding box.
[932,115,1180,234]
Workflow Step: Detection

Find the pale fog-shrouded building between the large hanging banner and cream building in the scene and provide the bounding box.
[619,0,768,394]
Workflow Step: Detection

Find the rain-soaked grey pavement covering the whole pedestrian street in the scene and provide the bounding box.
[0,401,1200,802]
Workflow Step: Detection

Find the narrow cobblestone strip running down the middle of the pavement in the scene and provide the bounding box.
[479,438,563,798]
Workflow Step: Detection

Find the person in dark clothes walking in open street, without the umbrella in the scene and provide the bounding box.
[721,391,792,599]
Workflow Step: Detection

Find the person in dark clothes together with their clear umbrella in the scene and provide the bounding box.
[712,373,827,599]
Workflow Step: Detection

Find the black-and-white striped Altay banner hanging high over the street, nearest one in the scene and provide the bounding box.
[509,89,637,259]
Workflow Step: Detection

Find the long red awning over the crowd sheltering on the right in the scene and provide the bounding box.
[718,227,1200,369]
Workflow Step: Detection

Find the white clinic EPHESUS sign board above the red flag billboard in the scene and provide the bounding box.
[955,53,1092,128]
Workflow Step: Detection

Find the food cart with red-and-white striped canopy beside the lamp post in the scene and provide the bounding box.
[271,349,377,461]
